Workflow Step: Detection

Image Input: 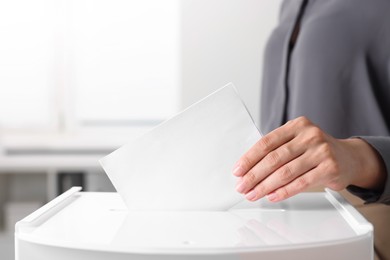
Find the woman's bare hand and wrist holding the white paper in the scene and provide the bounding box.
[233,117,386,202]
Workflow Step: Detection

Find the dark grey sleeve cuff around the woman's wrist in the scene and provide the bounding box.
[347,136,390,205]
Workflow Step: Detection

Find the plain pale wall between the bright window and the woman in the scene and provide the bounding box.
[181,0,281,128]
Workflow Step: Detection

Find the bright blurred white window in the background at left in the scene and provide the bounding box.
[0,0,179,130]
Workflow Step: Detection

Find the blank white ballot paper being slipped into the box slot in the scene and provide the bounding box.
[100,83,260,210]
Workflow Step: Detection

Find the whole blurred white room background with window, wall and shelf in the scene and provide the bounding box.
[0,0,280,260]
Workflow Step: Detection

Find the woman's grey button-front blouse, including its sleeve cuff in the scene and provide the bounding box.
[261,0,390,204]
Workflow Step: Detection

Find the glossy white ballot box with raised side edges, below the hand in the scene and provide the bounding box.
[15,187,373,260]
